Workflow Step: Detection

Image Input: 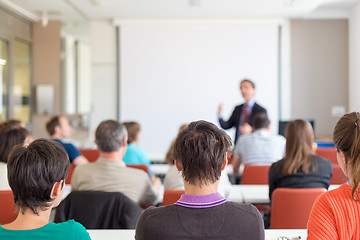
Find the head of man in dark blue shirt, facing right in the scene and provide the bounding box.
[46,115,72,139]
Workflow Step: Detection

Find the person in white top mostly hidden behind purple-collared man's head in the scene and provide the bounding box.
[164,124,231,197]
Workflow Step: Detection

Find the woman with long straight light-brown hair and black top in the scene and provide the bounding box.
[269,119,332,199]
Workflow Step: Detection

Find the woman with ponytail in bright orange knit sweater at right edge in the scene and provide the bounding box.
[308,112,360,240]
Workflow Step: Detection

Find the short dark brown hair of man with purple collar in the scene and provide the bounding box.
[173,121,231,184]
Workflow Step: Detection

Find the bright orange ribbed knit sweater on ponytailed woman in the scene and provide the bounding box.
[308,184,360,240]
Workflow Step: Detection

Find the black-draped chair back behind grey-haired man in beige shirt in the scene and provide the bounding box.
[54,191,142,229]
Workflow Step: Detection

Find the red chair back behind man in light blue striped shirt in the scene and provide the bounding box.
[241,164,270,184]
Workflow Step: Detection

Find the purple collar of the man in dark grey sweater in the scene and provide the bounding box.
[175,193,226,208]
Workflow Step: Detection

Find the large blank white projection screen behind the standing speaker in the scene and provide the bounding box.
[119,22,279,160]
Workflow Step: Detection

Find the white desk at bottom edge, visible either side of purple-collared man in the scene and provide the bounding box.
[87,228,307,240]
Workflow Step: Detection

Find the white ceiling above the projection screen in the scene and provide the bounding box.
[0,0,360,21]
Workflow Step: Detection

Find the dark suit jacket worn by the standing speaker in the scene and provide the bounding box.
[219,103,266,143]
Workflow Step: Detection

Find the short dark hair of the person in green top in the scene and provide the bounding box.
[7,139,70,214]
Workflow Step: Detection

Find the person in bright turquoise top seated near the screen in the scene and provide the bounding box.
[123,122,152,176]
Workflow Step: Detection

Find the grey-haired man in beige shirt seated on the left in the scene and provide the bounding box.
[71,120,162,205]
